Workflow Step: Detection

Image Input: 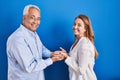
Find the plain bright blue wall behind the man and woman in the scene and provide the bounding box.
[0,0,120,80]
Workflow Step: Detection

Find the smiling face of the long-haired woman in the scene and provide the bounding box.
[73,18,86,38]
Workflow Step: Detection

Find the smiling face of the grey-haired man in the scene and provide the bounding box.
[23,8,40,32]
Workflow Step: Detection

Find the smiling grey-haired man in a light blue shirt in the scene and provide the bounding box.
[7,5,63,80]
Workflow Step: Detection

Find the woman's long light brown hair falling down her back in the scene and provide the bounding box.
[75,15,98,58]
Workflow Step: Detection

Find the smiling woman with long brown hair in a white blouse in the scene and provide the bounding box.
[61,15,98,80]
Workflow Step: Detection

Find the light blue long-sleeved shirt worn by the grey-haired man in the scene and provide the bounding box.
[7,25,53,80]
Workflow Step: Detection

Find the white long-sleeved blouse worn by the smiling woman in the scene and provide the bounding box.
[65,37,97,80]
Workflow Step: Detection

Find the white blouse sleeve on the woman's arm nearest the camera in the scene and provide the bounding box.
[65,39,90,75]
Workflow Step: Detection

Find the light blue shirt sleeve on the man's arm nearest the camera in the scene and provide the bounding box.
[11,38,53,73]
